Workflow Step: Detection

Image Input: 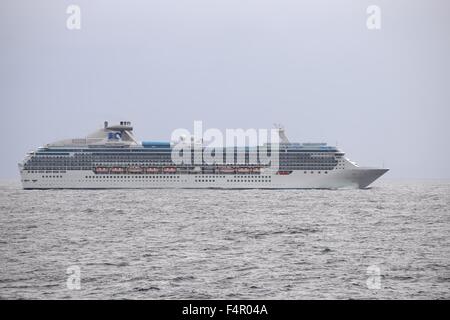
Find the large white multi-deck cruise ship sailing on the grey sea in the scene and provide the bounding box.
[19,121,388,189]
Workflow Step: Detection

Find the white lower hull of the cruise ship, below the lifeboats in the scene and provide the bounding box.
[20,166,388,189]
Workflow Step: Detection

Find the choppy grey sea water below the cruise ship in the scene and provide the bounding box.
[0,181,450,299]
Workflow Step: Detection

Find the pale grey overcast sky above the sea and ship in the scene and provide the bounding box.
[0,0,450,179]
